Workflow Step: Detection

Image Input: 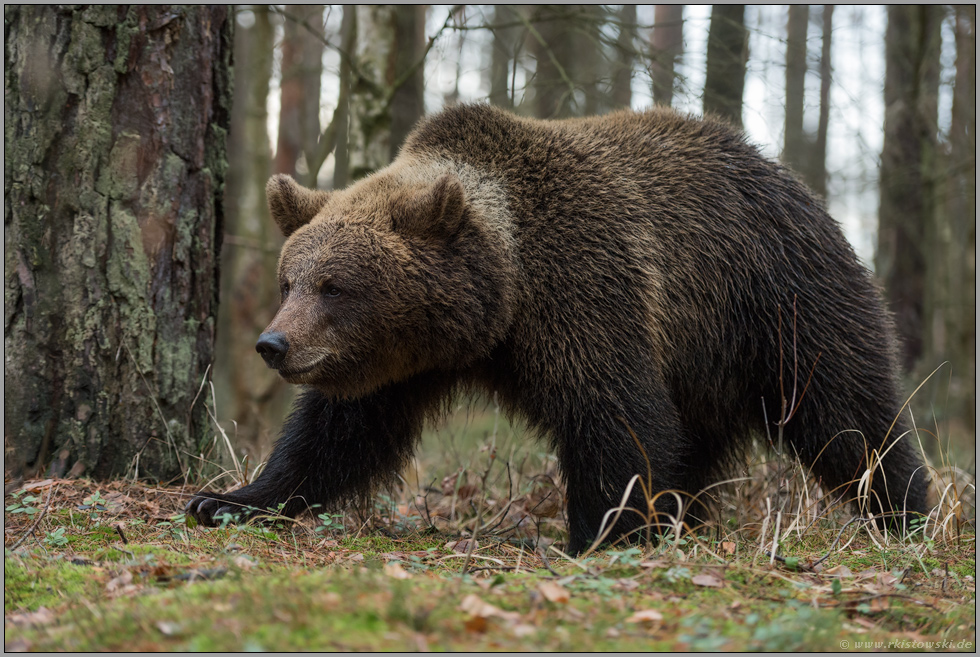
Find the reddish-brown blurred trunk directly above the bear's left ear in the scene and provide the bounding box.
[276,5,324,188]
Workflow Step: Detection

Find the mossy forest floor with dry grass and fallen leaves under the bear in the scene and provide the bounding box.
[4,408,976,652]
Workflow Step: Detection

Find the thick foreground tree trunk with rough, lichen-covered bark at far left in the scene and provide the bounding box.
[4,5,232,479]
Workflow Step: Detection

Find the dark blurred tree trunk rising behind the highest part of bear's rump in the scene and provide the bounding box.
[704,5,749,127]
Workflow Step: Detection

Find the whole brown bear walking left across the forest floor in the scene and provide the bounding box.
[187,105,929,552]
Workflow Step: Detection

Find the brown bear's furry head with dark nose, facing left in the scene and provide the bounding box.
[256,169,512,398]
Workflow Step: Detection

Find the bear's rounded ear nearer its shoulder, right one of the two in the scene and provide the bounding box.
[391,173,466,239]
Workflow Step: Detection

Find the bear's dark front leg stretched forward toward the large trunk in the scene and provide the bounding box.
[185,377,446,526]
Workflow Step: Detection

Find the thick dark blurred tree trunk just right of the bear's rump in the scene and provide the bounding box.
[875,5,943,371]
